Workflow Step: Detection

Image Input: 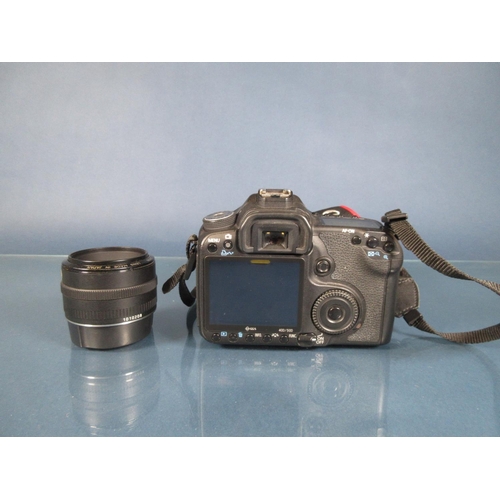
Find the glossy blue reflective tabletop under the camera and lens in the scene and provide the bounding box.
[0,256,500,436]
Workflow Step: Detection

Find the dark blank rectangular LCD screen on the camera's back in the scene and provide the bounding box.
[207,258,302,328]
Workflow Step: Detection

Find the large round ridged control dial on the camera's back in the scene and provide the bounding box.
[311,289,360,335]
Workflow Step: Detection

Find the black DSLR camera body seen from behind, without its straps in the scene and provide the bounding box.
[196,189,403,347]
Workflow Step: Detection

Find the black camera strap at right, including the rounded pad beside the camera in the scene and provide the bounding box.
[382,209,500,344]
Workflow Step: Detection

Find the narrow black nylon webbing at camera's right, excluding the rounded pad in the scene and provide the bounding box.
[382,209,500,344]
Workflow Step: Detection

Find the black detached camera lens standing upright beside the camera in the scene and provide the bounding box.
[61,247,157,349]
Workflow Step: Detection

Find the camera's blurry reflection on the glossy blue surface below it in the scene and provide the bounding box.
[200,348,388,436]
